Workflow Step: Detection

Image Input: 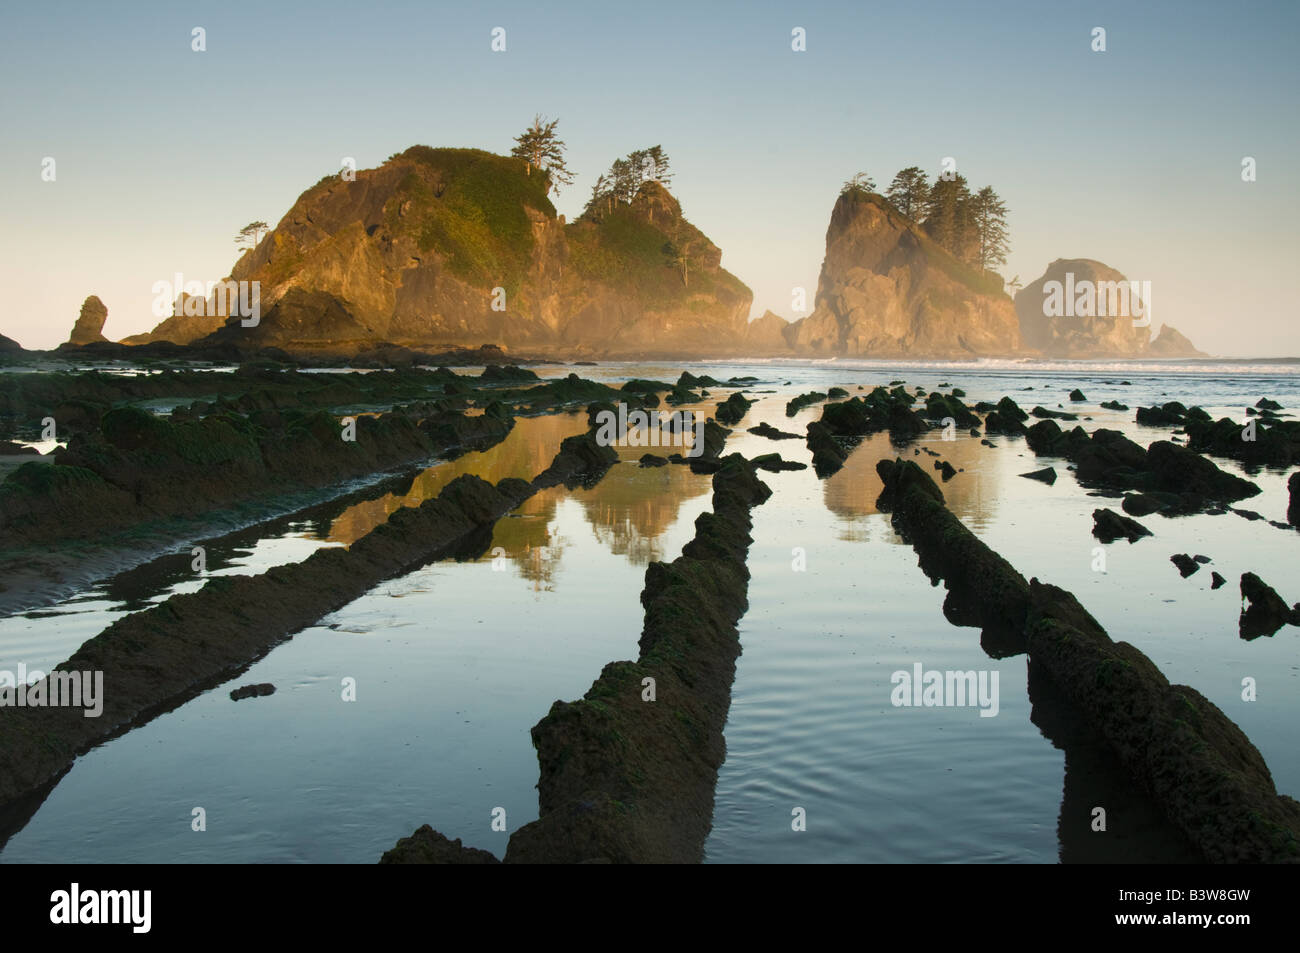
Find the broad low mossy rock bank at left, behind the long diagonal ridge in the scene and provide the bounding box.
[0,397,514,543]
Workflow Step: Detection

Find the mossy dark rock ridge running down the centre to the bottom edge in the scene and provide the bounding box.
[506,454,771,863]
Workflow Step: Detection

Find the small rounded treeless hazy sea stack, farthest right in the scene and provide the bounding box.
[1015,259,1205,359]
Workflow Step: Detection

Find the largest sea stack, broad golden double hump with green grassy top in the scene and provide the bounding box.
[137,146,753,358]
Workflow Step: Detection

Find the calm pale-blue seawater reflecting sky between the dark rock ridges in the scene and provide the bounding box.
[0,361,1300,863]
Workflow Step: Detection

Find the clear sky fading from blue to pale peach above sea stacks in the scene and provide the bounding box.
[0,0,1300,356]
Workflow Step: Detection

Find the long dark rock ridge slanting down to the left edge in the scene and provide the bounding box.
[0,432,618,806]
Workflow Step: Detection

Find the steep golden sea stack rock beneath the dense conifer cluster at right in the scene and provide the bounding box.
[788,191,1021,358]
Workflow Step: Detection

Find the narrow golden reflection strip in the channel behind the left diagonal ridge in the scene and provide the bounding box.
[329,413,586,546]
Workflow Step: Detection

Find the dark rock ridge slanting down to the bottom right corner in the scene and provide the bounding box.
[878,460,1300,863]
